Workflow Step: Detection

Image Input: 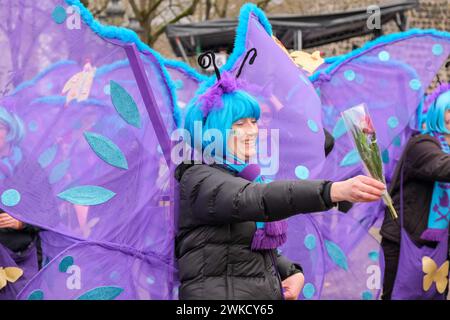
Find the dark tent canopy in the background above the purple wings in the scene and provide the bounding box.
[166,0,418,57]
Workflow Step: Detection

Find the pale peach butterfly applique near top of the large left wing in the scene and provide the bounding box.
[62,62,97,103]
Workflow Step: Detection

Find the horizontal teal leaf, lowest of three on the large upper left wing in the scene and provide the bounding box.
[58,185,116,206]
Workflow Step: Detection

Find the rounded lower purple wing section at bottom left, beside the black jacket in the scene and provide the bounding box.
[18,241,174,300]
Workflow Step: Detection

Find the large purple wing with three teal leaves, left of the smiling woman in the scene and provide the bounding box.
[0,0,175,299]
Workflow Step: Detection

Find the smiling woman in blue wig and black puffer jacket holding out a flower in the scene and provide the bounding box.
[175,49,385,300]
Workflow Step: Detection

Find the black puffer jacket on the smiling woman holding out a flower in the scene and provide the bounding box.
[176,164,333,300]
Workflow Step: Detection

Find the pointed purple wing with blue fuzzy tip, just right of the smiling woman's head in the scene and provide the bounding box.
[219,4,325,179]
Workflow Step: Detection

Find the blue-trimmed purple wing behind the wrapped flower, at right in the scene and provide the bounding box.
[304,30,450,299]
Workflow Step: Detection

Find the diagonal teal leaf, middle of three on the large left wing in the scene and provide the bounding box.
[84,132,128,169]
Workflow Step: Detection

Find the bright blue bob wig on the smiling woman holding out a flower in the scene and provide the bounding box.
[184,90,261,154]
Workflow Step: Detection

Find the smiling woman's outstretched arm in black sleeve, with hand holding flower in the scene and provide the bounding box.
[180,165,384,224]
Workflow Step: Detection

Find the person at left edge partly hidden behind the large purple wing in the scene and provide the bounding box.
[0,107,40,300]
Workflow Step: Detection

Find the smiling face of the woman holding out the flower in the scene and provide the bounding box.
[227,118,258,161]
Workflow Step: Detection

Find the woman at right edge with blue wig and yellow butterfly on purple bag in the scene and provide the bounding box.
[381,84,450,299]
